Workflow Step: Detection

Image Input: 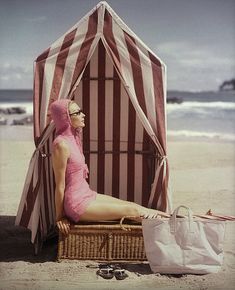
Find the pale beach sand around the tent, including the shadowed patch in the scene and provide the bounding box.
[0,130,235,290]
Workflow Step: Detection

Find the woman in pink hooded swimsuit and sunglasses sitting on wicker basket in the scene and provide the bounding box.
[50,99,169,234]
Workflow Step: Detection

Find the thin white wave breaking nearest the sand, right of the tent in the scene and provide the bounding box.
[167,130,235,142]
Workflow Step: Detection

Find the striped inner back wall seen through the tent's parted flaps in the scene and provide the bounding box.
[70,40,156,206]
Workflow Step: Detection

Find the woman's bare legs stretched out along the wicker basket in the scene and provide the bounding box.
[80,193,168,221]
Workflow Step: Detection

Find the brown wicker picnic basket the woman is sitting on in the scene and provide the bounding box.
[57,217,147,262]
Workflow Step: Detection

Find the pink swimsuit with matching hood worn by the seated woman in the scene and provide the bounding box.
[50,99,97,222]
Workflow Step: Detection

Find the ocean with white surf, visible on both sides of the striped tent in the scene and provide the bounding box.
[0,90,235,142]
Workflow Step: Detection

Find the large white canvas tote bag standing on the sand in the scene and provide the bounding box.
[142,206,225,274]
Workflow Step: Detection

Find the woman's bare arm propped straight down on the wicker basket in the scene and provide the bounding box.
[52,141,70,233]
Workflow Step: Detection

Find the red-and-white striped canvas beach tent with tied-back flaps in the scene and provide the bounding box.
[16,2,171,250]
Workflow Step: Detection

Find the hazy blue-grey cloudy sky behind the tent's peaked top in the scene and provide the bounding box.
[0,0,235,91]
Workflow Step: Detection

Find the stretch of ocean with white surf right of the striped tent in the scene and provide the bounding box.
[167,91,235,142]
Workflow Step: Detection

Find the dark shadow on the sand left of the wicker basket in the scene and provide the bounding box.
[0,216,58,263]
